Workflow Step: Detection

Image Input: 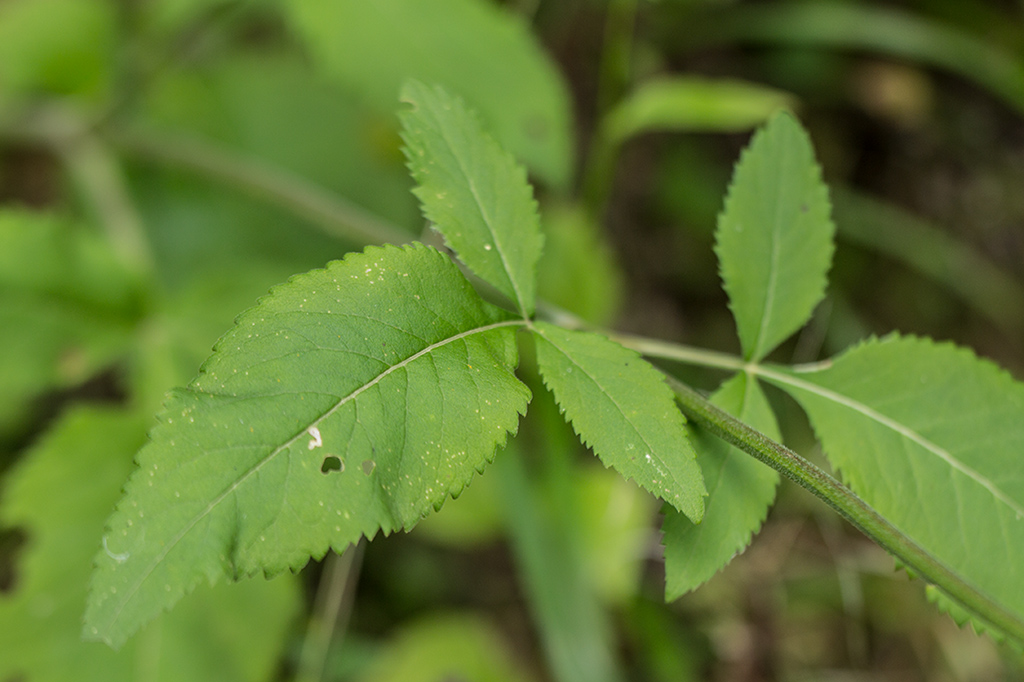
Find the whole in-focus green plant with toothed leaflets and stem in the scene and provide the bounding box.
[79,76,1024,646]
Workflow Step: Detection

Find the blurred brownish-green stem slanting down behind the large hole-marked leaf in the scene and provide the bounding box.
[113,133,413,244]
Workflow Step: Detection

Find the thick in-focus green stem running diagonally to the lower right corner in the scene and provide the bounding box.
[668,377,1024,643]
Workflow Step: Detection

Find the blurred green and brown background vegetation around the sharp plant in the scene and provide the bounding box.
[0,0,1024,682]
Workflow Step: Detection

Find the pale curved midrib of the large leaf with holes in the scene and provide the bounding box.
[99,319,525,641]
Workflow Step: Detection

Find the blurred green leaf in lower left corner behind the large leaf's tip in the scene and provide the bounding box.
[0,409,300,682]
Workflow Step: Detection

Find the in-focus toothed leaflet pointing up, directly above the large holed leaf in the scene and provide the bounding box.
[400,81,544,316]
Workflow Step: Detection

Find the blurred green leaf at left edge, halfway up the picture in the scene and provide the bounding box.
[0,210,140,432]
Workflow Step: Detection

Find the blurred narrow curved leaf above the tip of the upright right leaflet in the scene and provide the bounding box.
[604,76,793,144]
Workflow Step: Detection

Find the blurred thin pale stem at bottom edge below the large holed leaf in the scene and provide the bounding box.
[296,542,362,682]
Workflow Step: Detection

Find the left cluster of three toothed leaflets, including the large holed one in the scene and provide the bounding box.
[85,83,705,646]
